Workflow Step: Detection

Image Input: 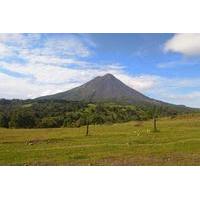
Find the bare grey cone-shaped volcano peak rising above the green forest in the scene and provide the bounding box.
[39,74,157,103]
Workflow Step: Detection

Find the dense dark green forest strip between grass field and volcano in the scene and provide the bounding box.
[0,99,194,128]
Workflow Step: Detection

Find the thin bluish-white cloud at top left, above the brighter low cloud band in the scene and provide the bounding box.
[0,34,92,57]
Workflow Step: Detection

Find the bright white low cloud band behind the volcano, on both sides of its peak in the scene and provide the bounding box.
[0,62,158,98]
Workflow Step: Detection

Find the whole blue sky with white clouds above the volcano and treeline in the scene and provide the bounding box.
[0,34,200,107]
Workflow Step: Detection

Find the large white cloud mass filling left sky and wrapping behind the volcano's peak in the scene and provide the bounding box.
[0,34,158,99]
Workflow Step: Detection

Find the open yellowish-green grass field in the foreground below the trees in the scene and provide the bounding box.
[0,116,200,165]
